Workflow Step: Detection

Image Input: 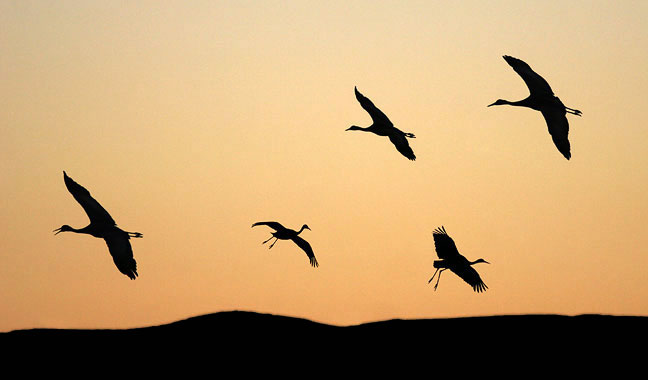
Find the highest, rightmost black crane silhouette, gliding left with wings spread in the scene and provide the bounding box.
[488,55,582,160]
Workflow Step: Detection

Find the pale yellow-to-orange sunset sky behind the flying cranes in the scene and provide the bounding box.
[0,1,648,331]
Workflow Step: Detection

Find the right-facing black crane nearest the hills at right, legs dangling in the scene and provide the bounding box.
[428,226,490,293]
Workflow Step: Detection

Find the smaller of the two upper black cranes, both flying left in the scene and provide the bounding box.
[347,87,416,161]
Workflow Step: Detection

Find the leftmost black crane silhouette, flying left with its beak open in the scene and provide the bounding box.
[53,171,142,280]
